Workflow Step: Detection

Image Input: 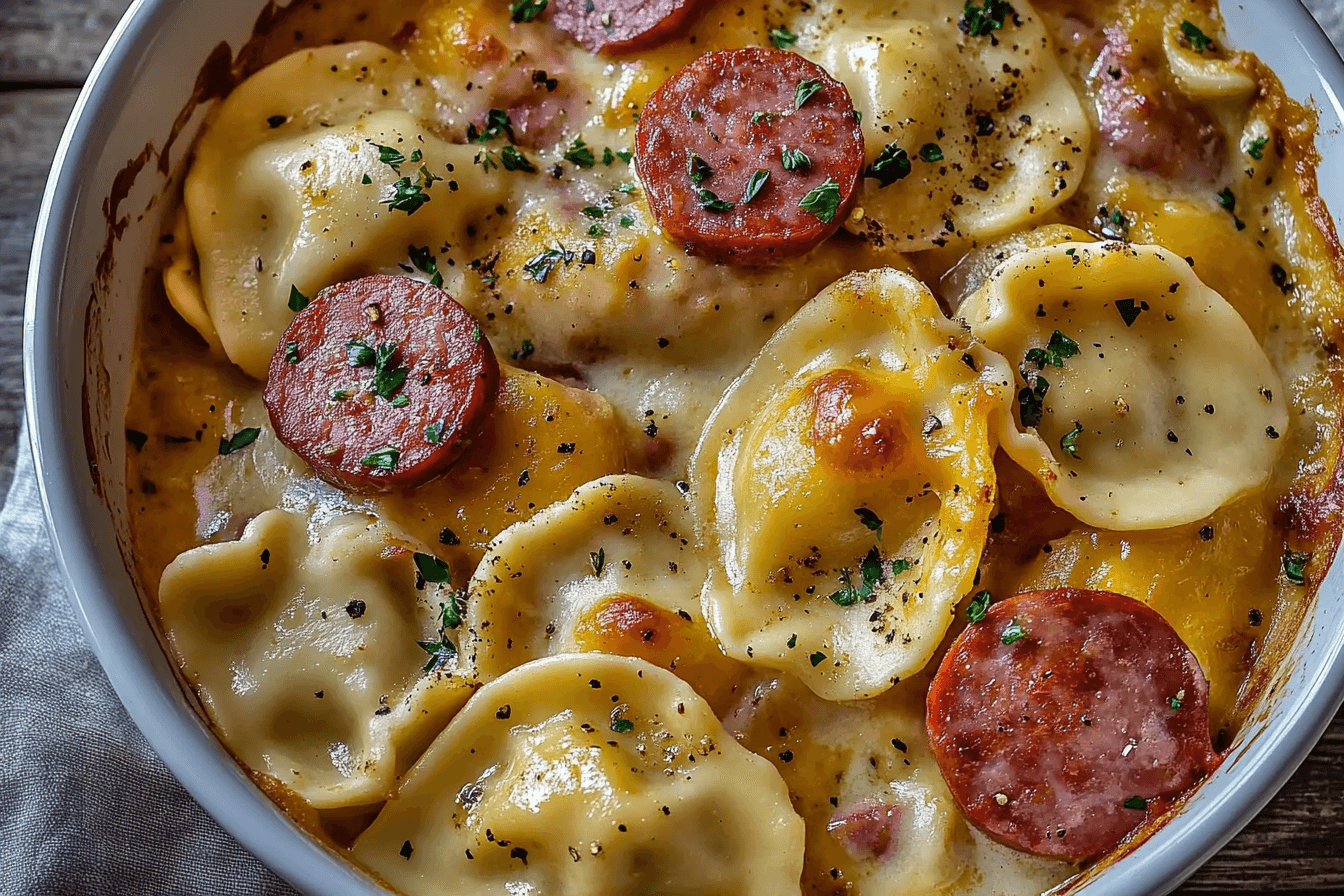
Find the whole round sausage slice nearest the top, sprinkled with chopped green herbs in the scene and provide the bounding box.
[636,47,864,265]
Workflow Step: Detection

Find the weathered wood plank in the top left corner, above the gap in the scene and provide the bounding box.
[0,0,130,86]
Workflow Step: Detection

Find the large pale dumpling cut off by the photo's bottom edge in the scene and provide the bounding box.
[351,653,804,896]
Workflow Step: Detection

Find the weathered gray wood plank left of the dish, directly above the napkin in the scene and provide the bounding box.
[0,90,78,494]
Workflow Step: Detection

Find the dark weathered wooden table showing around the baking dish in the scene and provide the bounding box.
[0,0,1344,893]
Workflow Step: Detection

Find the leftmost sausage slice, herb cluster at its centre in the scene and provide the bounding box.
[265,275,499,492]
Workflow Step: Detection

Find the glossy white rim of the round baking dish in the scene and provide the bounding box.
[23,0,1344,896]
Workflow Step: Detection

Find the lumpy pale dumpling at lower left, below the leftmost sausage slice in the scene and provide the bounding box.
[159,510,474,809]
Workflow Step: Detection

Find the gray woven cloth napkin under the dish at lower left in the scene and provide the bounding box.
[0,0,1344,896]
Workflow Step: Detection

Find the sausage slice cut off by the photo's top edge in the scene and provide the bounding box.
[551,0,700,55]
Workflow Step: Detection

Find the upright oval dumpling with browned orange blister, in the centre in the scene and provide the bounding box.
[691,270,1012,700]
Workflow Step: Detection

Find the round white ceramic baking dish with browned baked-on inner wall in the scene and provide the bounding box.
[24,0,1344,896]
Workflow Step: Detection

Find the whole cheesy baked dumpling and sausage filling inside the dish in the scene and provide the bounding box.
[126,0,1344,896]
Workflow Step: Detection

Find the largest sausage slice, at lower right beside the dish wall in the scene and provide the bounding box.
[927,588,1216,860]
